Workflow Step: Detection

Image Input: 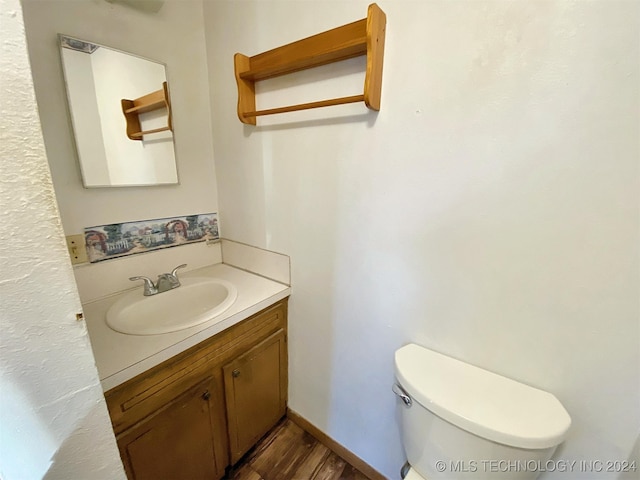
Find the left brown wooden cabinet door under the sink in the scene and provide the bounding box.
[117,377,226,480]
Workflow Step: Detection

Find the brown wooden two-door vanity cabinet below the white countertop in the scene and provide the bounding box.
[105,299,287,480]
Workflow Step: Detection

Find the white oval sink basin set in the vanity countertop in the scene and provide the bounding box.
[107,277,238,335]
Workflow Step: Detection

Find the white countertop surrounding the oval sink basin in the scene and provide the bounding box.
[83,263,291,392]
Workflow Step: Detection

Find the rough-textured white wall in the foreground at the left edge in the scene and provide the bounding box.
[0,0,126,480]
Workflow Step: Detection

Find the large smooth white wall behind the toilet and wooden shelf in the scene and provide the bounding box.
[204,0,640,479]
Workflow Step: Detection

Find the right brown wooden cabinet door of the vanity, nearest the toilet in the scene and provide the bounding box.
[223,329,287,464]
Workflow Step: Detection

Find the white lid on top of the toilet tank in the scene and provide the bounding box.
[395,344,571,449]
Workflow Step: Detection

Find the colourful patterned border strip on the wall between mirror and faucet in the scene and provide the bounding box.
[84,213,220,263]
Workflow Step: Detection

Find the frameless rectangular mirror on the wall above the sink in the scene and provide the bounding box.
[59,35,178,188]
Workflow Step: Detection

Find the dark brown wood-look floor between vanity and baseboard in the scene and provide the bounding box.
[227,418,369,480]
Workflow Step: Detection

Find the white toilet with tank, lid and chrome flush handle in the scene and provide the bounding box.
[393,344,571,480]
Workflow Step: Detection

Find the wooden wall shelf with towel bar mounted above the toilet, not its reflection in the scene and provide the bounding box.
[234,3,387,125]
